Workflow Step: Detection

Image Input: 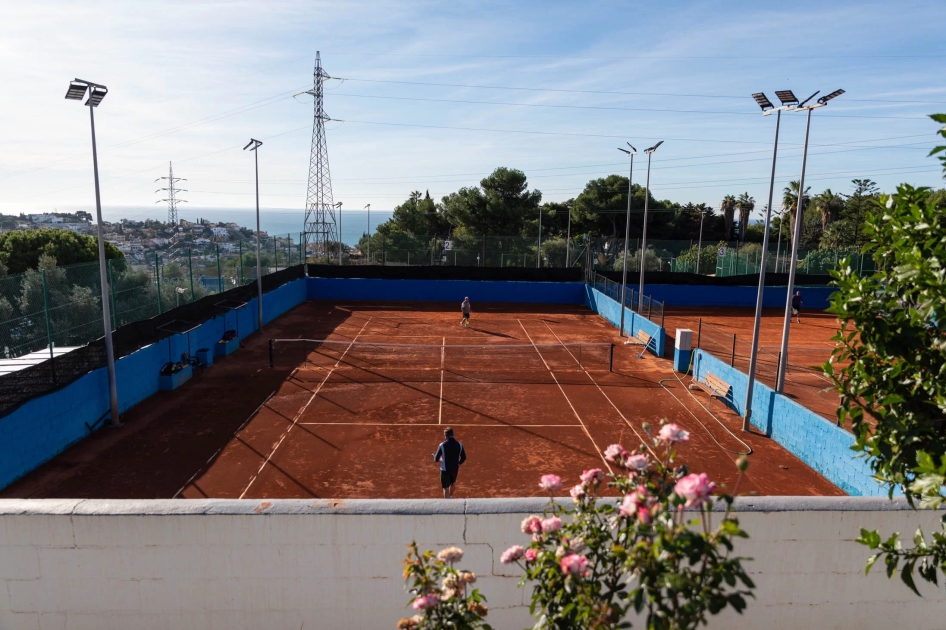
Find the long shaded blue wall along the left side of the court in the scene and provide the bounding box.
[0,279,306,488]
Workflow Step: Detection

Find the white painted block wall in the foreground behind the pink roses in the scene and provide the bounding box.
[0,498,946,630]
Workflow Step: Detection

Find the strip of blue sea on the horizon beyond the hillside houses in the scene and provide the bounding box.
[102,206,393,245]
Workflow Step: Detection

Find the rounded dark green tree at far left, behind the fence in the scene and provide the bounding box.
[0,228,125,273]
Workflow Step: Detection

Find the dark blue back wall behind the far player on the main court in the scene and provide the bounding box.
[308,278,585,308]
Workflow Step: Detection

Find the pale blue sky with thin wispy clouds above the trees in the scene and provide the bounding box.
[0,0,946,223]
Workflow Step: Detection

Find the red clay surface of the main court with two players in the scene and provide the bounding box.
[0,302,843,498]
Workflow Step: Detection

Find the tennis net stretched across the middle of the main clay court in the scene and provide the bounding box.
[269,339,614,373]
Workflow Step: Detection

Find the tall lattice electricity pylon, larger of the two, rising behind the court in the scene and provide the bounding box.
[305,51,341,262]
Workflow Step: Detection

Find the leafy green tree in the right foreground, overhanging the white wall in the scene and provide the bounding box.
[824,117,946,595]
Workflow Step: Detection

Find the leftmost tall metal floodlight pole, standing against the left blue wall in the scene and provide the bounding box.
[65,79,122,427]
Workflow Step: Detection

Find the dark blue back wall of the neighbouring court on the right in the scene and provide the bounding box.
[644,284,837,310]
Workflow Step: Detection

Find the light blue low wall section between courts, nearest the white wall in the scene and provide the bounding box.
[693,350,886,496]
